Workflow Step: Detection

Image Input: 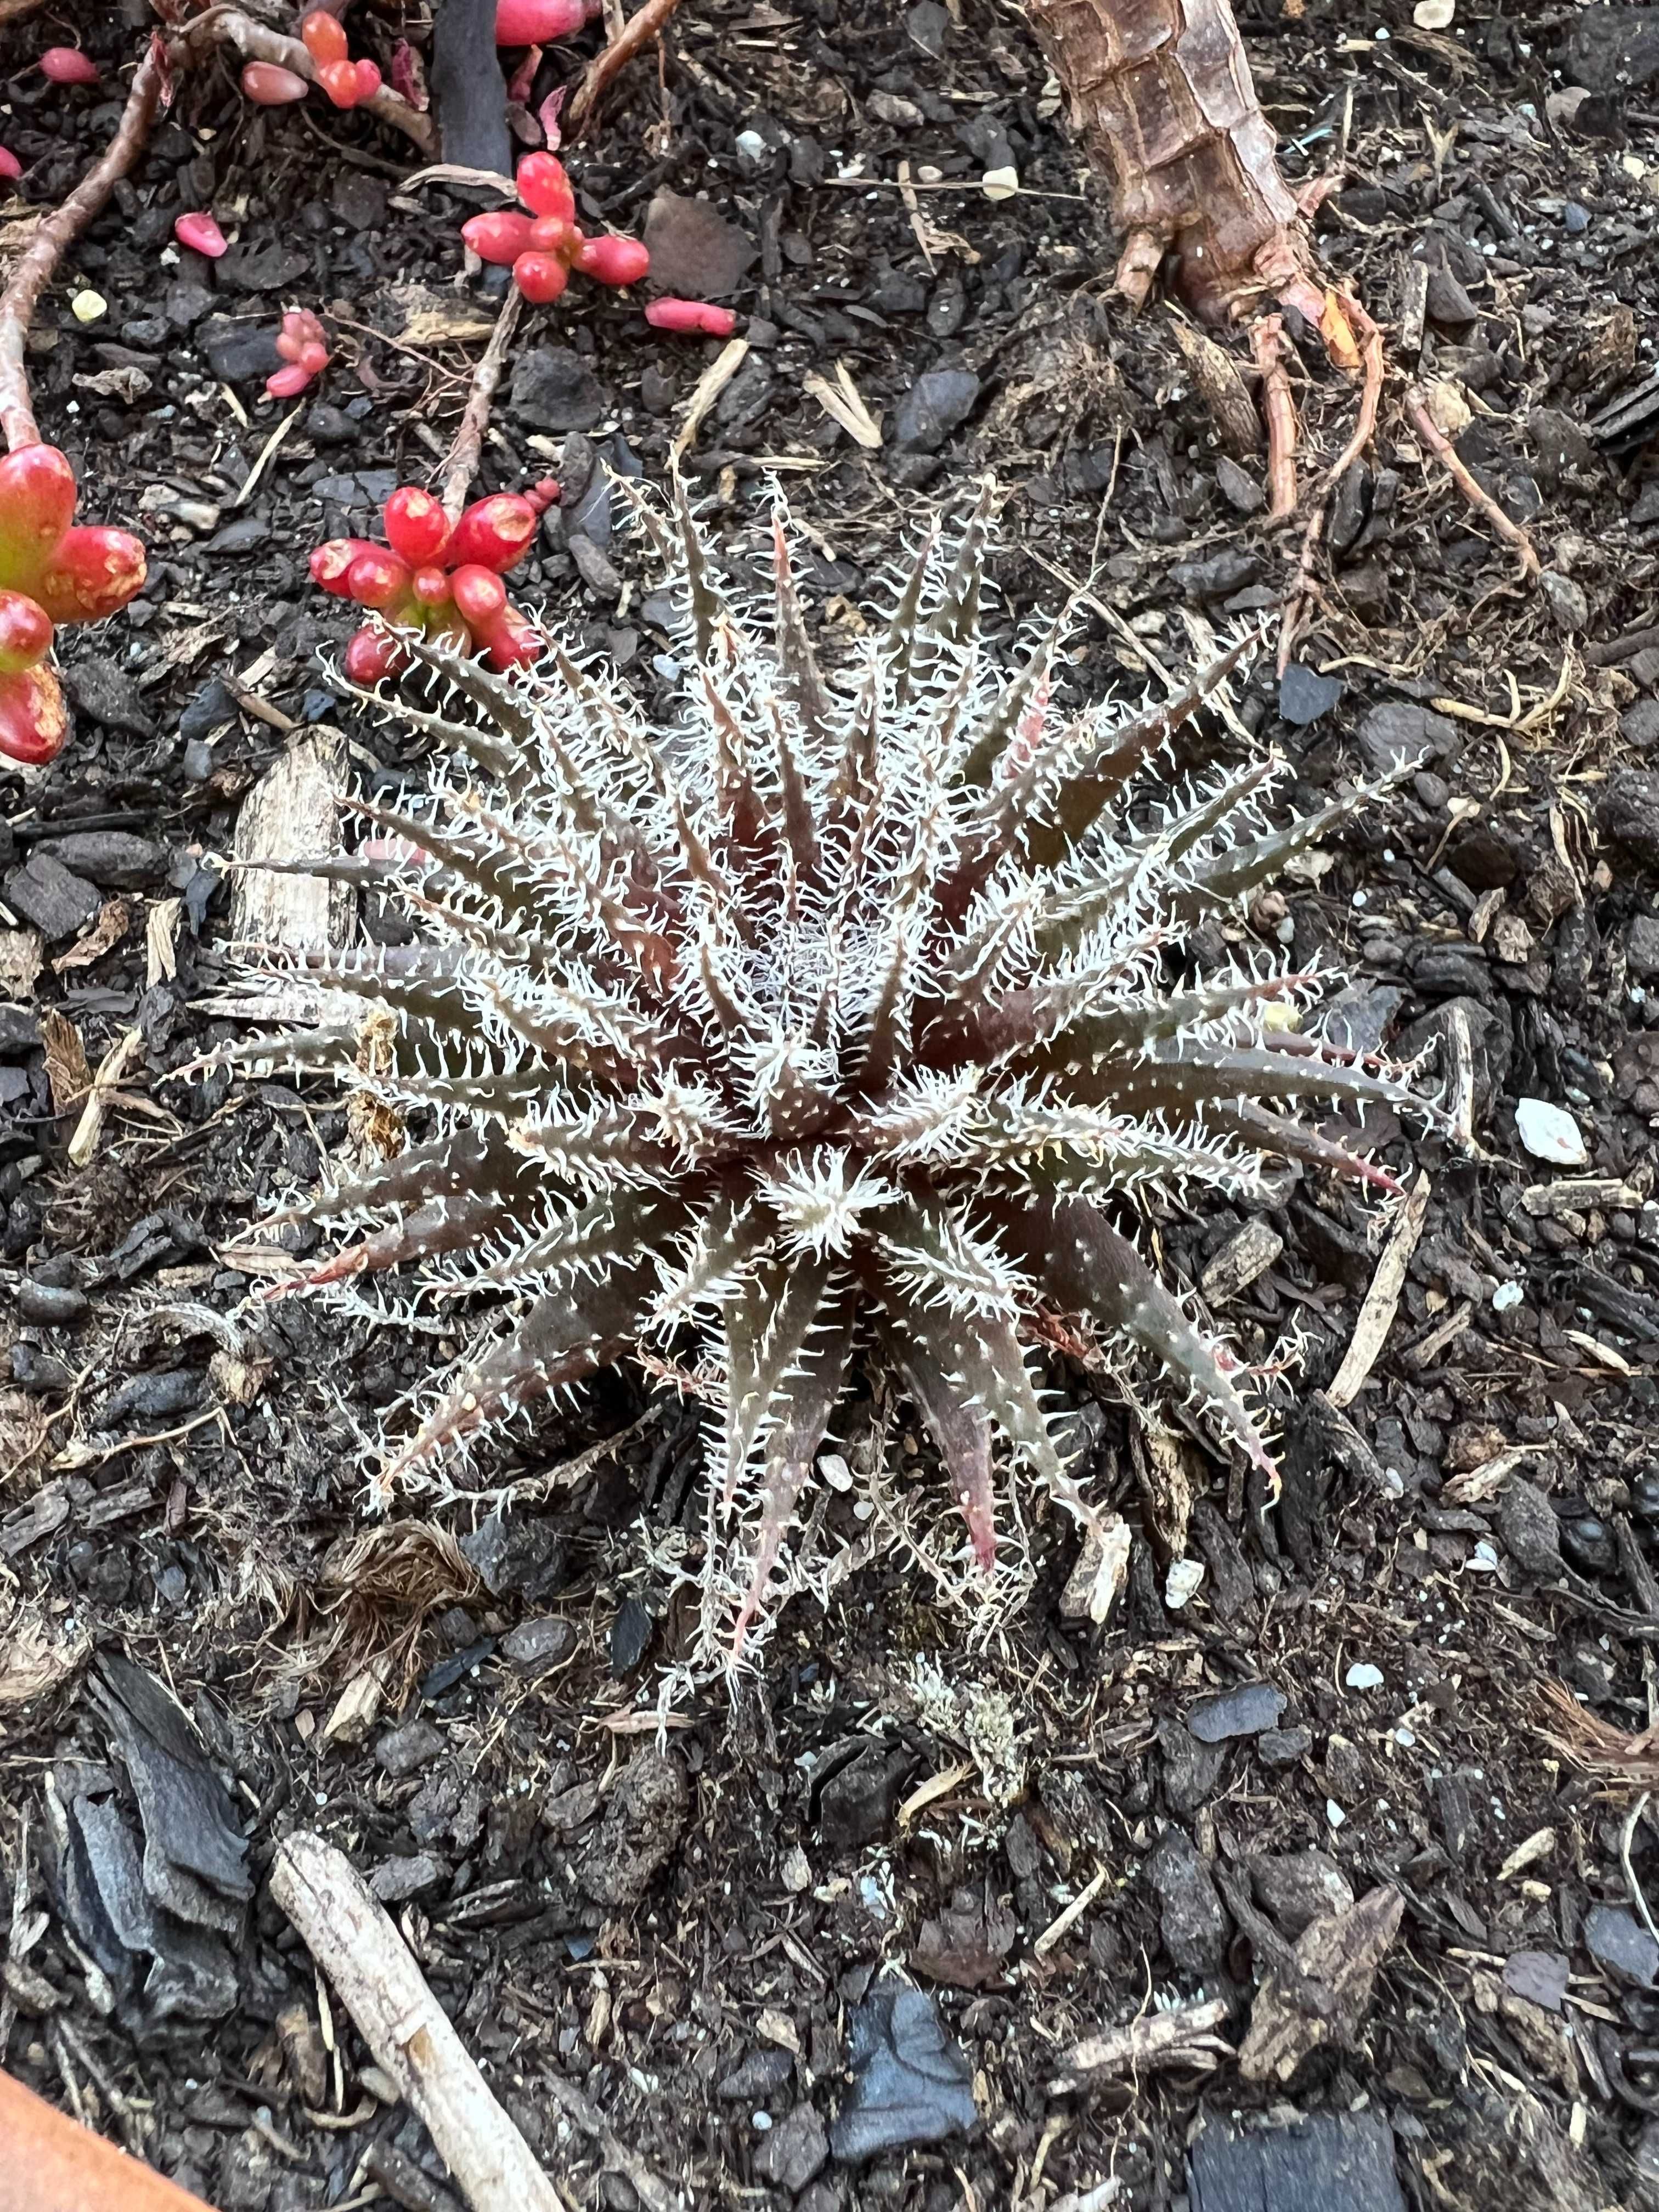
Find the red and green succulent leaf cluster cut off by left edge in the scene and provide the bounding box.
[0,444,144,765]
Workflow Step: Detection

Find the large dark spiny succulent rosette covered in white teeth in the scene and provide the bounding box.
[234,484,1442,1657]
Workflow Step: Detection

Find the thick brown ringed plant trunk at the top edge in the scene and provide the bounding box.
[1024,0,1318,323]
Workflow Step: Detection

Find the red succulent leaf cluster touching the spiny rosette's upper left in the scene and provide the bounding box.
[312,476,560,686]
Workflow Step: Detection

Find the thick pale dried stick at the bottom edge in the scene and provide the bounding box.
[270,1829,564,2212]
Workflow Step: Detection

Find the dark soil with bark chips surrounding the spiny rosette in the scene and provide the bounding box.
[0,0,1659,2212]
